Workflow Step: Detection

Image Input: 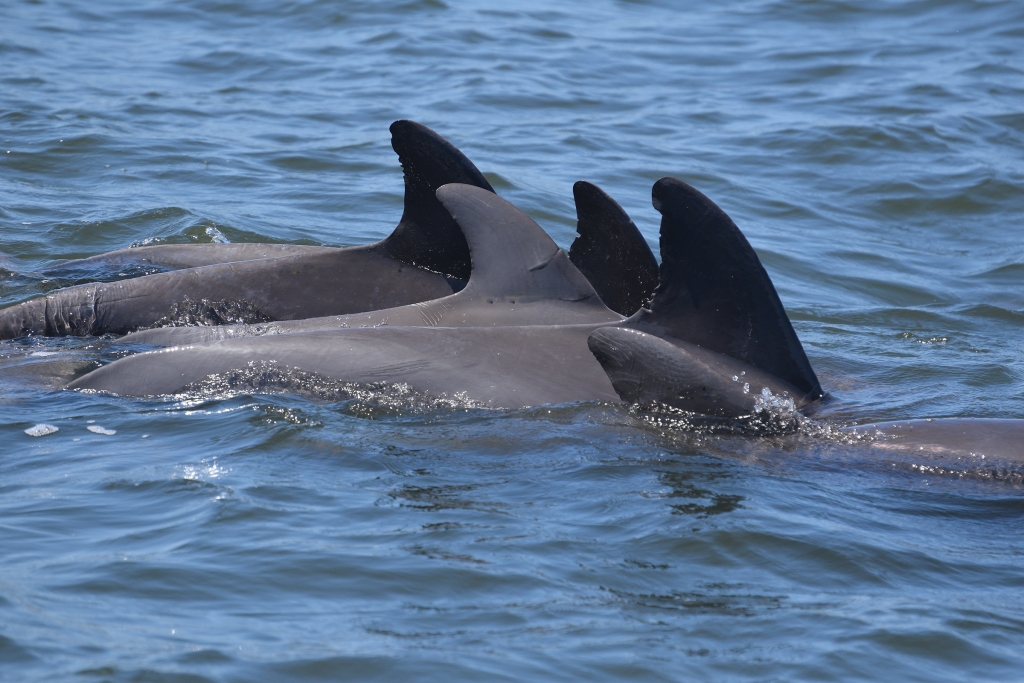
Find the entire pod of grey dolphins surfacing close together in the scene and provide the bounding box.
[6,121,1024,465]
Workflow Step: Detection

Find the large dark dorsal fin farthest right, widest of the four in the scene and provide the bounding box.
[630,178,821,399]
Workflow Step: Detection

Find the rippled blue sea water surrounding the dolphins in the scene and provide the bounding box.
[0,0,1024,681]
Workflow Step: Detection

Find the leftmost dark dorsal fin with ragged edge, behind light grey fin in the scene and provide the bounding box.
[383,121,495,280]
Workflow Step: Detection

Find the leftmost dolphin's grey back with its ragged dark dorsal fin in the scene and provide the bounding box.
[0,121,494,339]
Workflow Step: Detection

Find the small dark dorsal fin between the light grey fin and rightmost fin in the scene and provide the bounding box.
[569,180,657,315]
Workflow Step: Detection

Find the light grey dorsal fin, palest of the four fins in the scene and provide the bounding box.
[437,184,597,301]
